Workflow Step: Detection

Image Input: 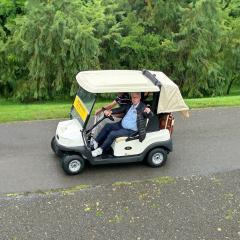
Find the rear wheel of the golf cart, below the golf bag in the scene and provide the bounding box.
[147,148,167,167]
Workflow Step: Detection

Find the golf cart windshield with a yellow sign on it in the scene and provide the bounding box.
[71,87,96,126]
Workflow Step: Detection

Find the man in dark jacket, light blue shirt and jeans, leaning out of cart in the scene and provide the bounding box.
[92,93,153,157]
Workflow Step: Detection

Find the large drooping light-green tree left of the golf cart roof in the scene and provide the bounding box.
[7,0,99,100]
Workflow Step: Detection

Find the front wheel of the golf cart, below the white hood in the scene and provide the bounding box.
[62,155,85,175]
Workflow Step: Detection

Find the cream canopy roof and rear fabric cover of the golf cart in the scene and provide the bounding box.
[76,70,189,116]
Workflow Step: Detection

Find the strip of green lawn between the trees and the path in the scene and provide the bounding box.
[0,95,240,123]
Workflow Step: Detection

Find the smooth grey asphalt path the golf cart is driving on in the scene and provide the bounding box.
[0,107,240,194]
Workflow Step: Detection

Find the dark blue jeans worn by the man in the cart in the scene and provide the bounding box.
[96,122,135,151]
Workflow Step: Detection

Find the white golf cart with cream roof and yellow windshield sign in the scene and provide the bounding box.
[51,70,188,175]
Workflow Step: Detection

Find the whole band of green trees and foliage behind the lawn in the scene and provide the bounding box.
[0,0,240,101]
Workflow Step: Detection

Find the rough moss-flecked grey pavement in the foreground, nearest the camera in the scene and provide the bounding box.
[0,170,240,240]
